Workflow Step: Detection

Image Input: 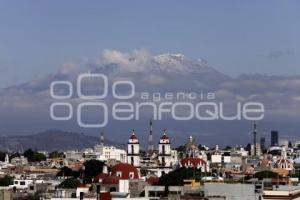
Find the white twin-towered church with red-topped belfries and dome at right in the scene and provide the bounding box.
[127,121,209,177]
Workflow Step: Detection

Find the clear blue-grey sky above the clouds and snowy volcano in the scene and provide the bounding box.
[0,0,300,88]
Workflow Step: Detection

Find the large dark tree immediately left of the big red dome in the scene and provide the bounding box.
[83,160,104,183]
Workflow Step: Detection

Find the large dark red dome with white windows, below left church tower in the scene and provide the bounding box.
[111,163,139,179]
